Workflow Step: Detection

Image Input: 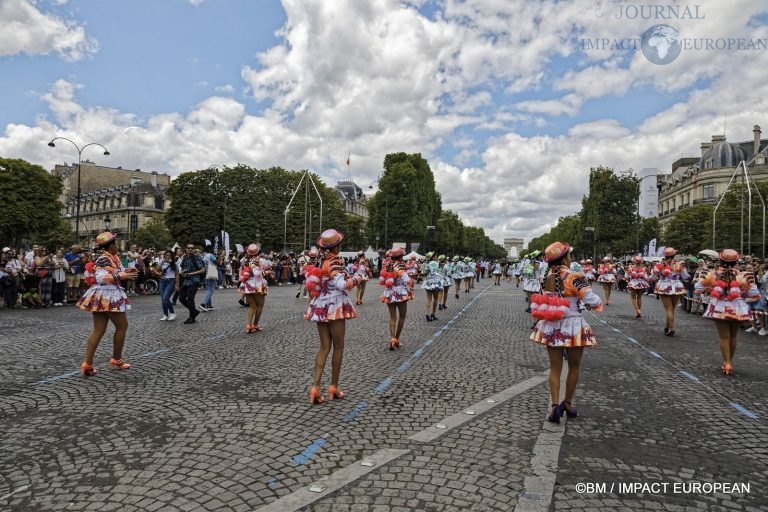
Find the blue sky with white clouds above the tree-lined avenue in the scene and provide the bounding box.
[0,0,768,242]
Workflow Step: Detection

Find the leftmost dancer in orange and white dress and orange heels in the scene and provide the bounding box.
[77,231,138,377]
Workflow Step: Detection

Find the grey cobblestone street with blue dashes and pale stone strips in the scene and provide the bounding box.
[0,279,768,512]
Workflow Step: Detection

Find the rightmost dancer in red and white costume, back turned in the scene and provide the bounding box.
[695,249,760,375]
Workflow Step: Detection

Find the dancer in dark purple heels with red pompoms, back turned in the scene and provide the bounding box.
[531,242,602,423]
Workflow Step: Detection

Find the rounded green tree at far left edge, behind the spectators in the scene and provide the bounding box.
[0,158,63,246]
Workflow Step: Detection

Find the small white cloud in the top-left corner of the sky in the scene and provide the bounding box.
[0,0,99,60]
